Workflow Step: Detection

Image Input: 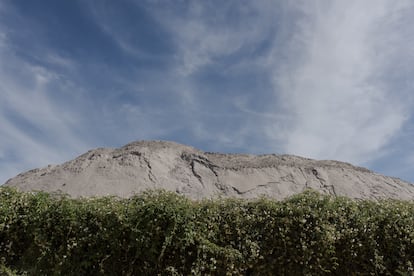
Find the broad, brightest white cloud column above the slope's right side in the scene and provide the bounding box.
[273,0,412,163]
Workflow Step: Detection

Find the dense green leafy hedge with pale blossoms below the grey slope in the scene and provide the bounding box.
[0,188,414,275]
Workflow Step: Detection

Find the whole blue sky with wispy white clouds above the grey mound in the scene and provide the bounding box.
[0,0,414,183]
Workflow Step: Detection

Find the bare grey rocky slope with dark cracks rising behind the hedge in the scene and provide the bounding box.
[5,141,414,200]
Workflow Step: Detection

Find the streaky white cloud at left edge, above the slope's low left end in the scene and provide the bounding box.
[0,33,89,184]
